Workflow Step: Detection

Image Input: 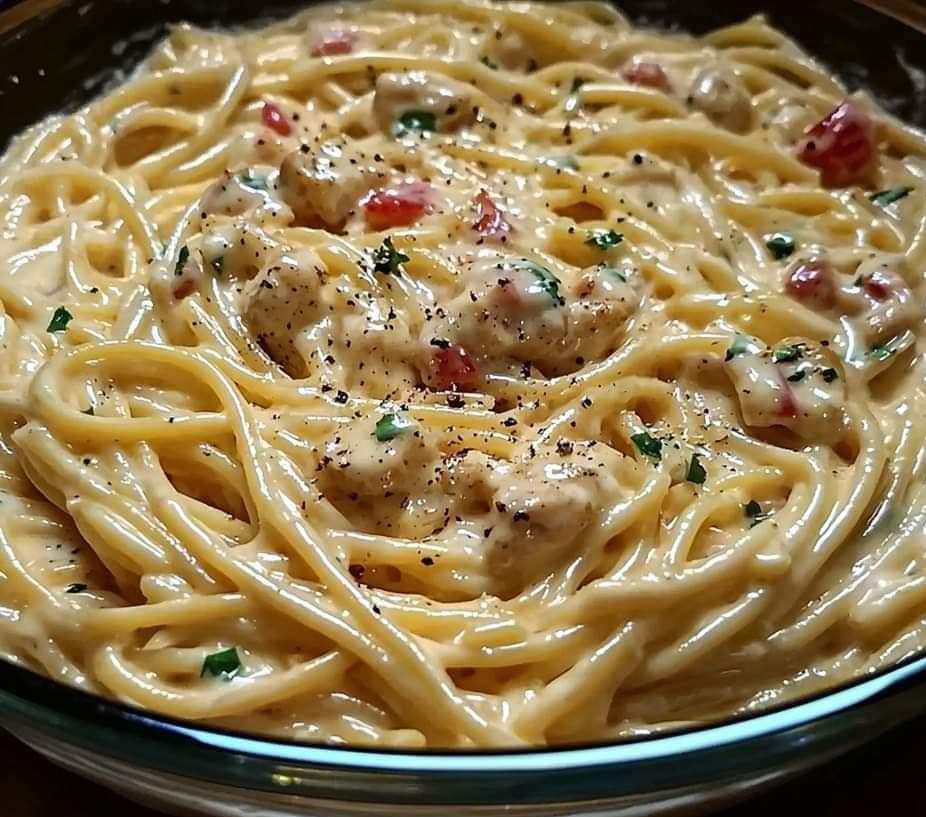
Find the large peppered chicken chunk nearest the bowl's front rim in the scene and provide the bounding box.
[444,440,625,599]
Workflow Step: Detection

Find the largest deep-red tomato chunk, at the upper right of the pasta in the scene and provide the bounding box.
[797,101,878,187]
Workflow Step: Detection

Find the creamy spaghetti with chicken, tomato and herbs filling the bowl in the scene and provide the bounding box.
[0,0,926,748]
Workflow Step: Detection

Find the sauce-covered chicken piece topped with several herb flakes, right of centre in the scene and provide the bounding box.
[724,338,846,444]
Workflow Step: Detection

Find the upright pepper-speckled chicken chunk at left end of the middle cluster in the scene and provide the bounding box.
[244,249,325,378]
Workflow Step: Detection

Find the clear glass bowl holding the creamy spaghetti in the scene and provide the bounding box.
[0,0,926,817]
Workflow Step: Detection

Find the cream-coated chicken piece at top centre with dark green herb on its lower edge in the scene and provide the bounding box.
[373,71,477,135]
